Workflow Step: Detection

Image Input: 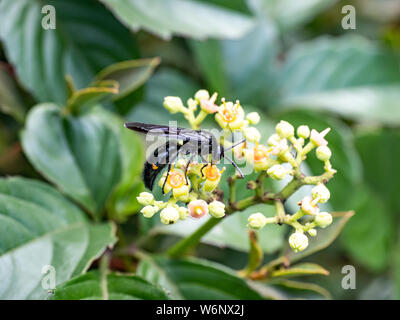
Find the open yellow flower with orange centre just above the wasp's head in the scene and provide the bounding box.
[215,99,244,130]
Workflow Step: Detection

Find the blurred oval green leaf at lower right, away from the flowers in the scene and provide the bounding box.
[341,186,396,272]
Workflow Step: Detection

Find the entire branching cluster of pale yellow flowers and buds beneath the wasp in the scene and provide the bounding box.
[137,90,336,252]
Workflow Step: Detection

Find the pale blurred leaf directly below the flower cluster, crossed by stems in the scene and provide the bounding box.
[152,204,286,253]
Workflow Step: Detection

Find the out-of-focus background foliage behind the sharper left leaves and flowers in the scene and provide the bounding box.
[0,0,400,299]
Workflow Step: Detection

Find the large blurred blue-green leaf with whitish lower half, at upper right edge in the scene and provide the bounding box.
[278,36,400,124]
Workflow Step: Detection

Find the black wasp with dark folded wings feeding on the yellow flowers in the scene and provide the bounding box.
[125,122,245,192]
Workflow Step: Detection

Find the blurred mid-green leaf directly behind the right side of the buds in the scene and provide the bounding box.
[282,111,362,211]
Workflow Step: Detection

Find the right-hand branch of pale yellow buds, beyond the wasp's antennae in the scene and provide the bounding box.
[243,121,336,252]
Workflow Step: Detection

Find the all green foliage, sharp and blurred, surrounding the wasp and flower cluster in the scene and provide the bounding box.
[0,0,400,299]
